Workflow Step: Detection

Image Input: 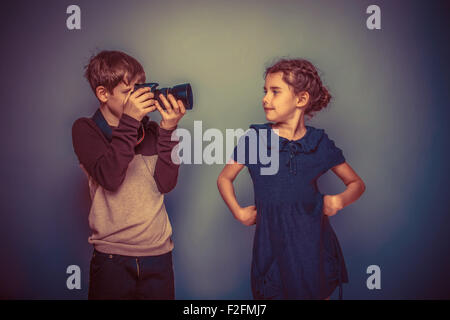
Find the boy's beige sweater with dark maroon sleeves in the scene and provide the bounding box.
[72,114,179,256]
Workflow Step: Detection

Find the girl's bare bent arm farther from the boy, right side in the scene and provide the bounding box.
[324,162,366,216]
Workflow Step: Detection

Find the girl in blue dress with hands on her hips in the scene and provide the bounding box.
[217,59,365,299]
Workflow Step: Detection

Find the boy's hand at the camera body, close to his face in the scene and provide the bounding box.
[123,87,156,121]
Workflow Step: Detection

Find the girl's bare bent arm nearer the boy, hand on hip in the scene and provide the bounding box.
[217,160,256,226]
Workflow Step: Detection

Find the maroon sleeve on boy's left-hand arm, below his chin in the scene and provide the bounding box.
[72,114,140,191]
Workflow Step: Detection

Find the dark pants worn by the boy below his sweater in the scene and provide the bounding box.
[88,250,175,300]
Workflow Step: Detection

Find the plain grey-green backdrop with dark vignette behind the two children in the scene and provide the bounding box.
[0,0,450,299]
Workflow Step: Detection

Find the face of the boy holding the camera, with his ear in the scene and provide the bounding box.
[100,77,142,119]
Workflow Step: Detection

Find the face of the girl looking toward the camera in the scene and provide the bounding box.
[262,72,304,123]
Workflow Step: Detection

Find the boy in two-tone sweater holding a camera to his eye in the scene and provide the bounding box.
[72,51,186,299]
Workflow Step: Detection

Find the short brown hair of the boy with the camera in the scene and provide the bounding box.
[84,50,145,94]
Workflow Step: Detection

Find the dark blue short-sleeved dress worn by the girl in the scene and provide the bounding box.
[233,123,348,299]
